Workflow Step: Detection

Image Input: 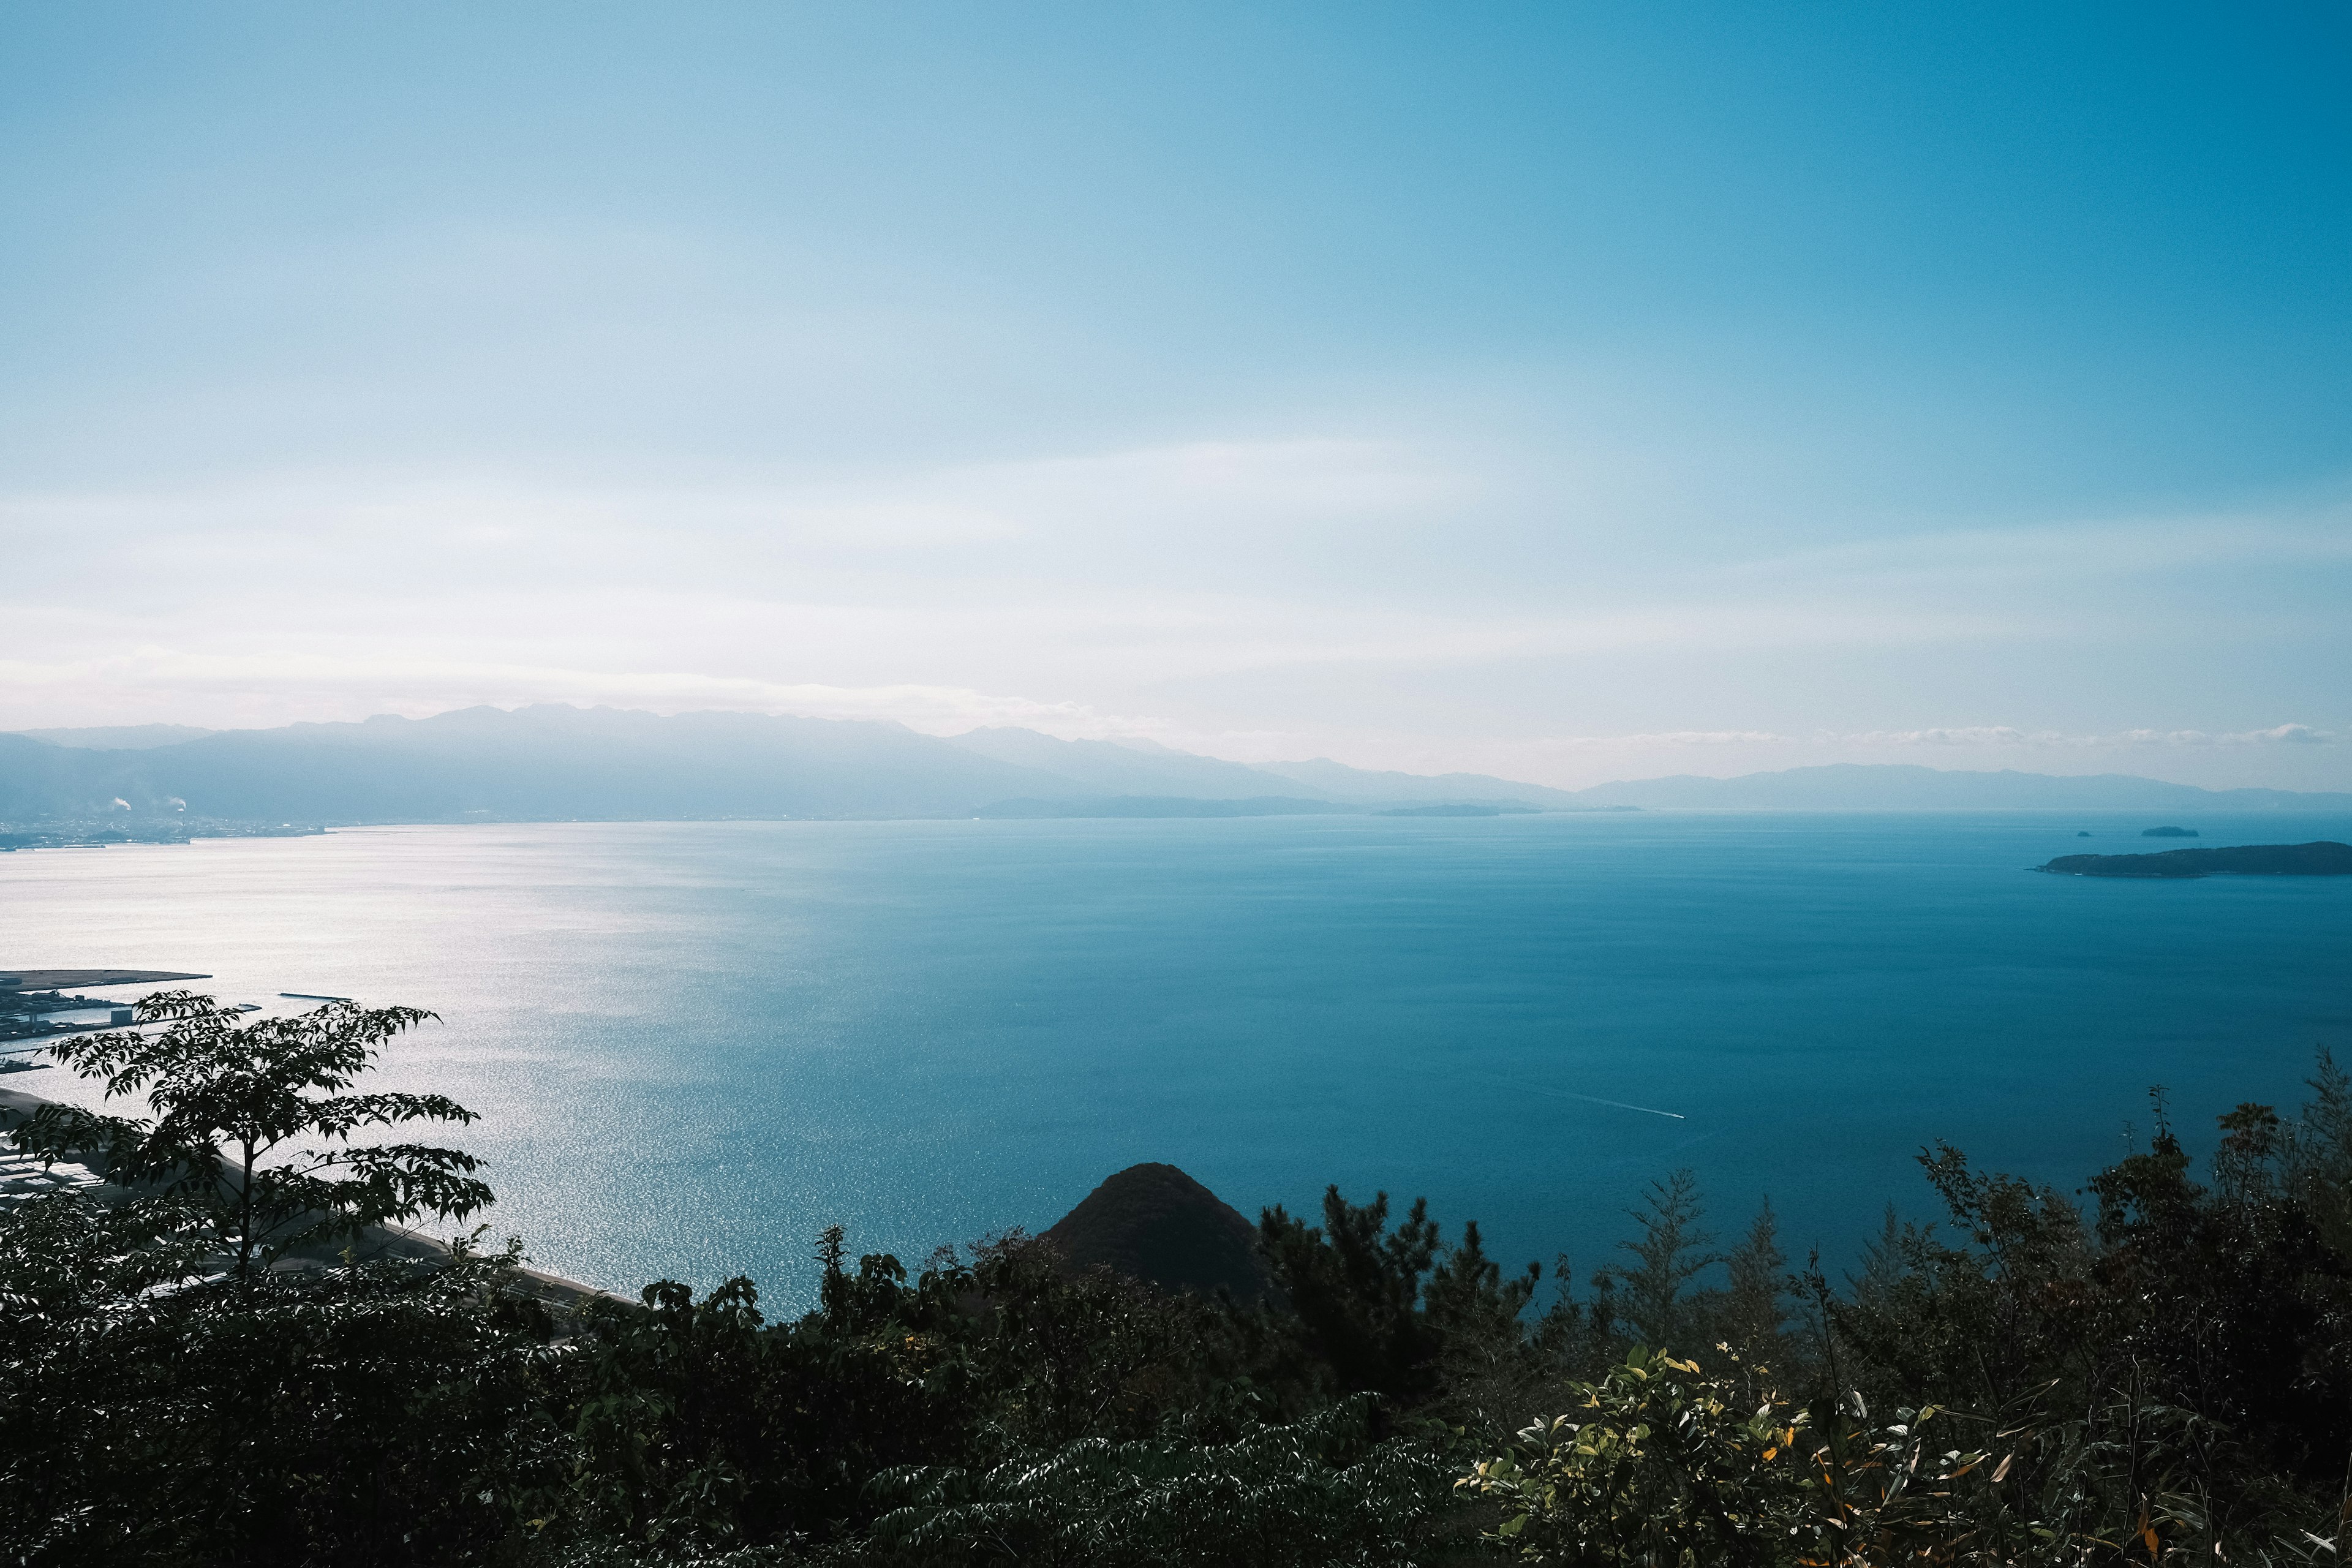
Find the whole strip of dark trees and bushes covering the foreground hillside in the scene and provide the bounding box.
[0,997,2352,1568]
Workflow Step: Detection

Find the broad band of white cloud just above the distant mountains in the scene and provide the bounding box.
[0,428,2352,799]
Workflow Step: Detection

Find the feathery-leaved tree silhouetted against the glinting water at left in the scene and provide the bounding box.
[14,992,492,1279]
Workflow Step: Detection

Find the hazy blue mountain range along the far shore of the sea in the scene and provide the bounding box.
[0,705,2352,823]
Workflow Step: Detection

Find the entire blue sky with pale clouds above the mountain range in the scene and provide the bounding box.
[0,5,2352,788]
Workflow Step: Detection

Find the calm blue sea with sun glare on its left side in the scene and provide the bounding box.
[0,813,2352,1302]
